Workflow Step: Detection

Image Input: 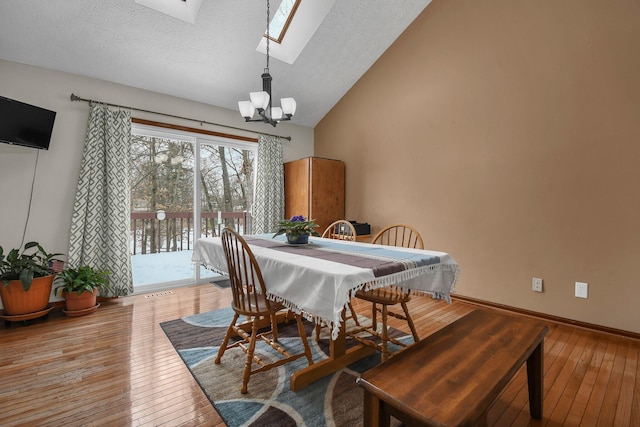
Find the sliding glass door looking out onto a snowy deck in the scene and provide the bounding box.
[130,125,257,292]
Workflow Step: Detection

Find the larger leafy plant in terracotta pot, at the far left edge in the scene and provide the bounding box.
[0,242,62,320]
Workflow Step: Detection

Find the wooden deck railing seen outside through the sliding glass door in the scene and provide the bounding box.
[131,212,248,255]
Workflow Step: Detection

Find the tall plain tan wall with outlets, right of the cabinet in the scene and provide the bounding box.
[315,0,640,332]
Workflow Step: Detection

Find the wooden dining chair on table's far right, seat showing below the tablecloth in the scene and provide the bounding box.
[352,224,424,362]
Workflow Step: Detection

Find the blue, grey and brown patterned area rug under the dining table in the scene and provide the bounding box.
[160,308,412,427]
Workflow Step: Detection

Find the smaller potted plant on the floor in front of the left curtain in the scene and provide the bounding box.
[55,265,111,316]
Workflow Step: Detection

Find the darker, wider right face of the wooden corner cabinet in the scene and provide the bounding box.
[309,158,345,234]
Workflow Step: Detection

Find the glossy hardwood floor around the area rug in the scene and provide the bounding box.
[0,285,640,426]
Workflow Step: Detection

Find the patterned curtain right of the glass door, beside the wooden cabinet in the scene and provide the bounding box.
[253,135,284,234]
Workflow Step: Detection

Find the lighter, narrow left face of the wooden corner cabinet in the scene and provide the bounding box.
[284,158,311,219]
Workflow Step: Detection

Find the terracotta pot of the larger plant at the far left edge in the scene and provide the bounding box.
[0,274,55,316]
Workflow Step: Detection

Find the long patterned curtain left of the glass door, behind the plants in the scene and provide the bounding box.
[68,103,133,295]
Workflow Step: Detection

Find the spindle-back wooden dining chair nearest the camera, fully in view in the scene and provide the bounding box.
[215,228,313,393]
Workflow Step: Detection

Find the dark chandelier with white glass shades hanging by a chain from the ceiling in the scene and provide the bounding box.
[238,0,296,127]
